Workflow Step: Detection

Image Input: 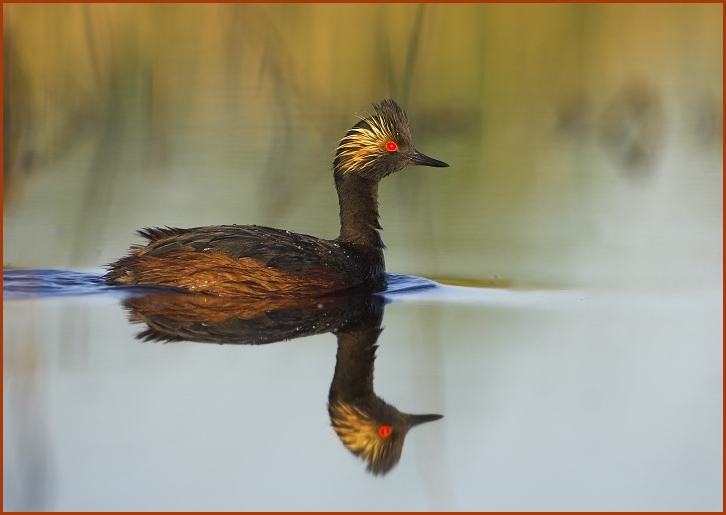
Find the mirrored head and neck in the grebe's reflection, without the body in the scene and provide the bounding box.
[328,296,442,475]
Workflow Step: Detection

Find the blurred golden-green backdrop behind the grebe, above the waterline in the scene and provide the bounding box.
[3,4,723,287]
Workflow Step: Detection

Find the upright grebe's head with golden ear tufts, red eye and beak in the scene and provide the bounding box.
[333,99,449,181]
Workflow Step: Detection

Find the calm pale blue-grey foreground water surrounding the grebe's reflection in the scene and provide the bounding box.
[3,271,722,510]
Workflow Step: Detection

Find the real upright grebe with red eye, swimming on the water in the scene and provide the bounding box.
[106,100,448,296]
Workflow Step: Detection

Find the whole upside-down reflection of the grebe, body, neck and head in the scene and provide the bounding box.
[124,290,441,475]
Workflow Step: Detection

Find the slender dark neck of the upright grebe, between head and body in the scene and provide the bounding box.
[335,174,384,251]
